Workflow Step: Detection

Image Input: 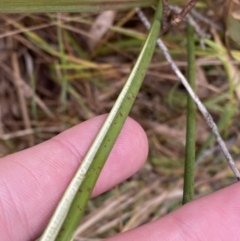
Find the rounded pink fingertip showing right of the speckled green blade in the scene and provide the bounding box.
[93,117,148,196]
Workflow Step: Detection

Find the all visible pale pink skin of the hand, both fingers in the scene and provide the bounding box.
[0,115,240,241]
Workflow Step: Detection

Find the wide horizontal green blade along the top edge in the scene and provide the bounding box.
[0,0,157,13]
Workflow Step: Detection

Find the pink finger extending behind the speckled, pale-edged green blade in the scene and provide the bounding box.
[0,116,147,241]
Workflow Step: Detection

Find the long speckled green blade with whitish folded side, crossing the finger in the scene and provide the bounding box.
[39,1,162,241]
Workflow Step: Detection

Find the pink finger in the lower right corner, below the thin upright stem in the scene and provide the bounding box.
[107,183,240,241]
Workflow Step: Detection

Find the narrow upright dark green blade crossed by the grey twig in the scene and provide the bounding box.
[183,24,196,204]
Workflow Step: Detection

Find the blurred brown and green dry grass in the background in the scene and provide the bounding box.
[0,0,240,240]
